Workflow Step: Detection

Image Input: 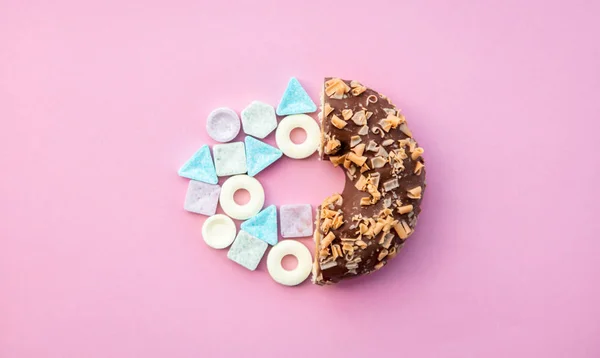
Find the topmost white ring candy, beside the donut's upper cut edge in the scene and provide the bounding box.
[275,114,321,159]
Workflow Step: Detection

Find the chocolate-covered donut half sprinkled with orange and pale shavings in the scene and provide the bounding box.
[312,78,425,285]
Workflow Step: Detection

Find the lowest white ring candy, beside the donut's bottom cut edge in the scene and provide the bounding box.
[267,240,312,286]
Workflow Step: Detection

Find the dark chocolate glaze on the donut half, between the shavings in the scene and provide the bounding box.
[313,78,425,284]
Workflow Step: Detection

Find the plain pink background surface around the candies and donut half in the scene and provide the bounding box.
[0,0,600,358]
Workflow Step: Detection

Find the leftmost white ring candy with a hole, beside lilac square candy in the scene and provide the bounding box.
[219,175,265,220]
